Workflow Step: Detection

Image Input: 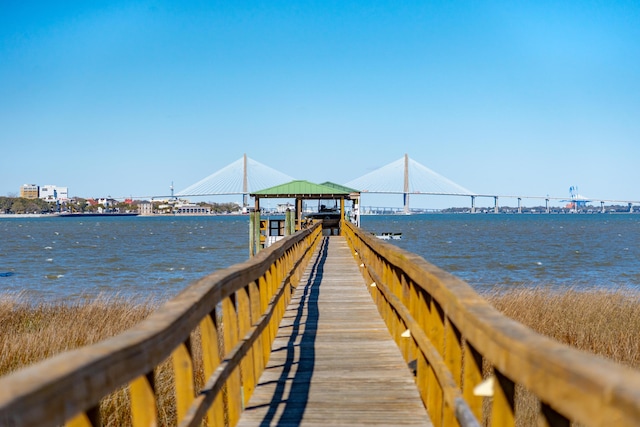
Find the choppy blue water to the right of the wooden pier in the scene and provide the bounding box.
[362,214,640,291]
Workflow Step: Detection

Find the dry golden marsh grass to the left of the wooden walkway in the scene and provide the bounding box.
[0,295,215,426]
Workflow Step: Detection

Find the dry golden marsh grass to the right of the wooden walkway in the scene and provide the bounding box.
[484,288,640,426]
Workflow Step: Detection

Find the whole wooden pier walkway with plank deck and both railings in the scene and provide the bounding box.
[0,219,640,427]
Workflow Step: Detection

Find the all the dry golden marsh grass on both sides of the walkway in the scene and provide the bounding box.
[0,289,640,425]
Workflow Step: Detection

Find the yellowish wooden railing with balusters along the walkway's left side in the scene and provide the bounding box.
[0,225,321,426]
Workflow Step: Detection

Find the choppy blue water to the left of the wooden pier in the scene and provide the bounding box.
[0,216,249,299]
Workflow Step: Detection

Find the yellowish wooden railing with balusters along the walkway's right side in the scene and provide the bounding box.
[343,222,640,426]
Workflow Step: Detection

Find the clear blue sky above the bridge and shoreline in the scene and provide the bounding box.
[0,0,640,209]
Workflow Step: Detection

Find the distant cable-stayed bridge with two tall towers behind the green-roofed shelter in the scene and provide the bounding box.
[176,154,640,213]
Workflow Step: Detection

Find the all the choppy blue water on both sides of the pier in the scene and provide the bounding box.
[0,214,640,300]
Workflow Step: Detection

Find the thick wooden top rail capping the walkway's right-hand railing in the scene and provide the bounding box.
[345,223,640,426]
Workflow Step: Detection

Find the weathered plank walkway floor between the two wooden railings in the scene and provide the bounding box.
[239,236,431,426]
